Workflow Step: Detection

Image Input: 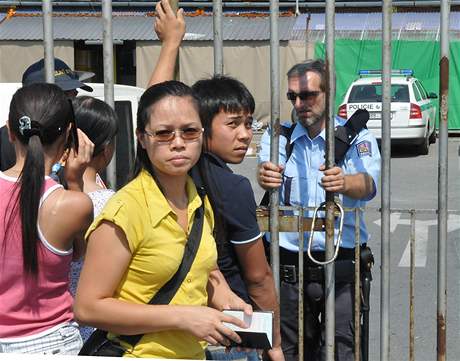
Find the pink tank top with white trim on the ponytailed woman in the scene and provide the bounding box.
[0,172,73,339]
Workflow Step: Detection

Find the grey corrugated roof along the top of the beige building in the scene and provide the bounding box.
[0,13,296,41]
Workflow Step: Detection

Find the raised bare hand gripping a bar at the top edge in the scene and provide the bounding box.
[155,0,185,46]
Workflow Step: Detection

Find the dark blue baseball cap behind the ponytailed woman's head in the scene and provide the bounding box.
[22,58,94,92]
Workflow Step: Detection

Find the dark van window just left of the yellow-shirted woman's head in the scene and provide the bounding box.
[115,100,134,189]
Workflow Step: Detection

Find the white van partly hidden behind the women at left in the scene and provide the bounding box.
[0,83,144,187]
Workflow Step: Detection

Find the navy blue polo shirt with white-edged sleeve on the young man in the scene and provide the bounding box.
[203,153,262,302]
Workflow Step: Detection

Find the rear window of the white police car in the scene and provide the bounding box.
[348,84,409,103]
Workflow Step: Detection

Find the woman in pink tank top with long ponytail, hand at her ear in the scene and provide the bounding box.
[0,84,93,354]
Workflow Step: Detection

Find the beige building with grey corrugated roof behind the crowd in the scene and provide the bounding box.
[0,13,312,123]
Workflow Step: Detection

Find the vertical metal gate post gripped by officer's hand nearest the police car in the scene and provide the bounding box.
[324,0,335,361]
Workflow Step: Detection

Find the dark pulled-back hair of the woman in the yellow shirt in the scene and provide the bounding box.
[132,80,198,178]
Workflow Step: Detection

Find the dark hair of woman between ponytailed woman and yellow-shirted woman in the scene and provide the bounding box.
[72,96,118,157]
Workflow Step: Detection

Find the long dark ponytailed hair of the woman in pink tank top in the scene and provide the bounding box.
[5,84,73,275]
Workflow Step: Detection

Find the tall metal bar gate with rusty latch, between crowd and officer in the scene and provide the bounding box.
[36,0,459,361]
